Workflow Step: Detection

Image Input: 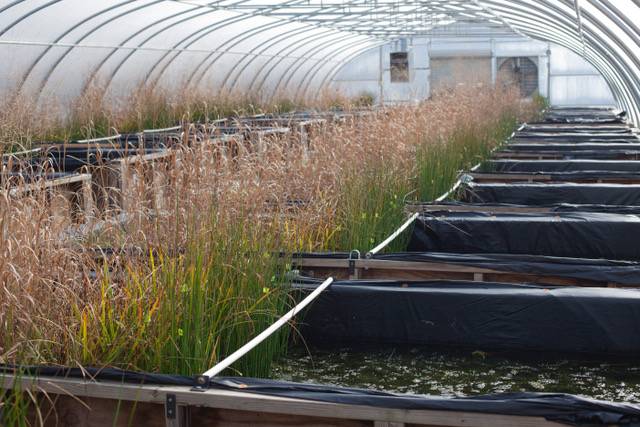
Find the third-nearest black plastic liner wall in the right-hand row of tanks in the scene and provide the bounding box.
[459,183,640,206]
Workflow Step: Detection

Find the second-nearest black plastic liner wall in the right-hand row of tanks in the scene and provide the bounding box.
[408,212,640,261]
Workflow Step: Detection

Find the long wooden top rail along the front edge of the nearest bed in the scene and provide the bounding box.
[0,374,563,427]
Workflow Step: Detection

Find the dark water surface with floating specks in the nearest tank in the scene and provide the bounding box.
[272,348,640,402]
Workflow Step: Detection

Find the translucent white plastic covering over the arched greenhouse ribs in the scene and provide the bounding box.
[0,0,640,123]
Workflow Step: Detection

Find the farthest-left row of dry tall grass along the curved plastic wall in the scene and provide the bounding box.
[0,85,350,149]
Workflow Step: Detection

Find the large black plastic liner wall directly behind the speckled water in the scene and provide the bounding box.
[298,280,640,357]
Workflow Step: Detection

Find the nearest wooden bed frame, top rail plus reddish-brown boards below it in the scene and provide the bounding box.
[0,374,564,427]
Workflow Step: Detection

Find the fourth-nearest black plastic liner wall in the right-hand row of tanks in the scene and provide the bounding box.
[480,159,640,172]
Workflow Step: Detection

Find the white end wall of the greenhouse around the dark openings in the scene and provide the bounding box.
[332,36,615,106]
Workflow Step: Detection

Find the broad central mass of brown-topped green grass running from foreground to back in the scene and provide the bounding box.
[0,83,536,392]
